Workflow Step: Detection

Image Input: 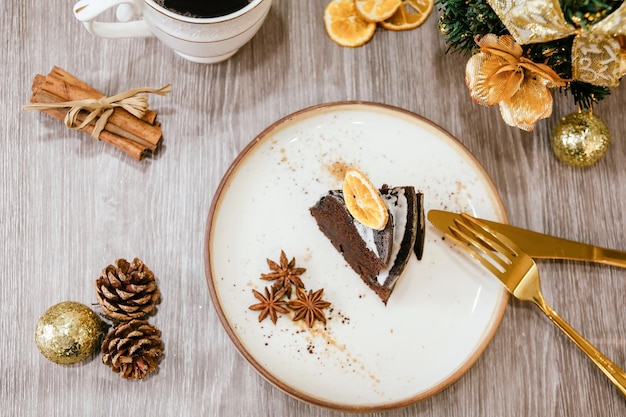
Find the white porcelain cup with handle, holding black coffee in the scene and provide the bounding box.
[74,0,272,63]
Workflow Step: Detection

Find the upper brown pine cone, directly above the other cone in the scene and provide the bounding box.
[95,258,161,321]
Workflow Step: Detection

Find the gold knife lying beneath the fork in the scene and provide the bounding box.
[428,210,626,268]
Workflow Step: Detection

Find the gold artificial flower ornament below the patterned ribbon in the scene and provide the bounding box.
[465,34,566,131]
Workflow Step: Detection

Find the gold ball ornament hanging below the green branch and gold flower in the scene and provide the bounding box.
[552,112,611,167]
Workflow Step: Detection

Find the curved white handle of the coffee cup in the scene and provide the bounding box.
[74,0,154,39]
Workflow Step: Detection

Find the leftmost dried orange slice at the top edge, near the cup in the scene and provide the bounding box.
[324,0,376,48]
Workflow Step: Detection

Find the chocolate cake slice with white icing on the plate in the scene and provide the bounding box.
[310,186,423,304]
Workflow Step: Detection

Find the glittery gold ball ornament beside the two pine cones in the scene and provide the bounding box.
[35,301,107,365]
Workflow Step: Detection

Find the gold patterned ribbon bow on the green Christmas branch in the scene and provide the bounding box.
[487,0,626,87]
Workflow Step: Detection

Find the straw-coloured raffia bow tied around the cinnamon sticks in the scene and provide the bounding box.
[24,84,172,139]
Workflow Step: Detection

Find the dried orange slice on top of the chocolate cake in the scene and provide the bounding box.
[343,168,389,230]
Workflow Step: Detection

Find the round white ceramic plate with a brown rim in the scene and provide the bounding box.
[206,102,508,411]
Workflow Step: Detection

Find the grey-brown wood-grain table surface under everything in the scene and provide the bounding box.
[0,0,626,417]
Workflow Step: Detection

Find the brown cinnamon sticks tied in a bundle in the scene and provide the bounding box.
[30,66,167,160]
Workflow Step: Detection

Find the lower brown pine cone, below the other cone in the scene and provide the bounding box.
[102,320,163,379]
